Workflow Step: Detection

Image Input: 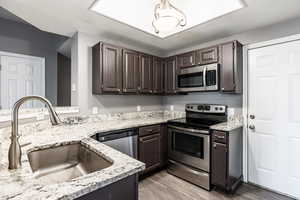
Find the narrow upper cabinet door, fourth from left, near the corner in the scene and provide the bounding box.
[153,57,164,94]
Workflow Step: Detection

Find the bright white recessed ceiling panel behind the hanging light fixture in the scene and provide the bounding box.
[91,0,245,38]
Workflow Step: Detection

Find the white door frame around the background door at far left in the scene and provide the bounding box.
[0,51,46,107]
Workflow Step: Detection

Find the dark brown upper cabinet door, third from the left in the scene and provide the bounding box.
[140,54,153,94]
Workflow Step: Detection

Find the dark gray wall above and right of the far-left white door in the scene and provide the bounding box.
[0,18,66,104]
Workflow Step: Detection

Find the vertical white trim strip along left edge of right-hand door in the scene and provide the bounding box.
[243,45,248,183]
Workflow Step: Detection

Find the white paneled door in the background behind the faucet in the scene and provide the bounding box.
[0,52,45,109]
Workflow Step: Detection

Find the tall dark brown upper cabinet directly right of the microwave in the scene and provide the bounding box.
[220,41,243,93]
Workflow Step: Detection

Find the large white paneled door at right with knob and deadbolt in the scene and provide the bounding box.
[248,41,300,198]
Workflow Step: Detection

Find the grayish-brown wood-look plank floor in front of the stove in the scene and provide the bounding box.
[139,171,292,200]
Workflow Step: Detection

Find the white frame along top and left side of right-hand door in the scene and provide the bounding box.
[243,34,300,183]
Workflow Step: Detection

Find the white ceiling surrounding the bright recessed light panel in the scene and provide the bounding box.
[0,0,300,52]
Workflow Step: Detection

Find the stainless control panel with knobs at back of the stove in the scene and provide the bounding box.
[185,104,227,113]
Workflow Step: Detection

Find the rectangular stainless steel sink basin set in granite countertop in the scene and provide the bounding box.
[28,143,113,184]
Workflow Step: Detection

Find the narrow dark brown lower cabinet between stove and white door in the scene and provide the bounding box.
[211,128,243,192]
